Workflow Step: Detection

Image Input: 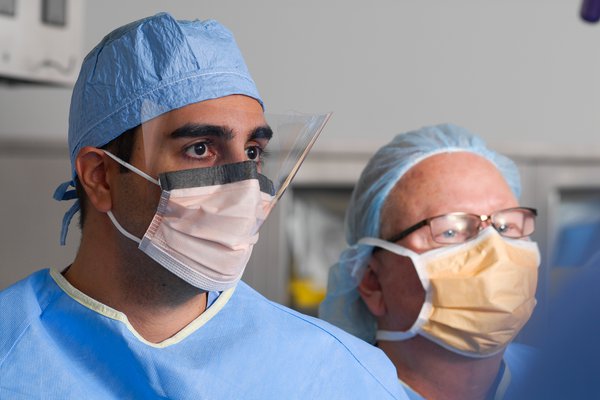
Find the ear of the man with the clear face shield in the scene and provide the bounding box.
[75,146,112,213]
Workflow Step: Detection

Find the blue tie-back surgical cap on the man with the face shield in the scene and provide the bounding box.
[54,13,263,244]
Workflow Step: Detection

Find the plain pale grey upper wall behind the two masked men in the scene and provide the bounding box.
[0,0,600,154]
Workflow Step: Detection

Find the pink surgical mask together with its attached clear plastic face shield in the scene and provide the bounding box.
[107,96,330,291]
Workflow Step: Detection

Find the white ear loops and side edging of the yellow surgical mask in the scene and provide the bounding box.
[358,237,432,341]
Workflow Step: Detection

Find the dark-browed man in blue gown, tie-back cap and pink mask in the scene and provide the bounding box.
[0,14,402,399]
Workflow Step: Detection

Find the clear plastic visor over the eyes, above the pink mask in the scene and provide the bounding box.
[136,99,331,207]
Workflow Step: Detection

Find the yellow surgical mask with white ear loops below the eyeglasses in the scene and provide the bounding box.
[359,227,540,357]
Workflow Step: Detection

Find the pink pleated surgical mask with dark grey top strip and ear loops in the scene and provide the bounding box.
[105,151,273,291]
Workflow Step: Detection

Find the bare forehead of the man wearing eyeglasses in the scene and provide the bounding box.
[381,152,518,232]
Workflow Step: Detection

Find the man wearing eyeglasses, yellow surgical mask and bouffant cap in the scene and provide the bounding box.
[320,125,539,399]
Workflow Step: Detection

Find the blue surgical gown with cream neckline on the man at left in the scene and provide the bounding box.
[0,270,405,400]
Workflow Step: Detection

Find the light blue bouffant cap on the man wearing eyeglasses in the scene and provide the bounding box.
[319,124,521,343]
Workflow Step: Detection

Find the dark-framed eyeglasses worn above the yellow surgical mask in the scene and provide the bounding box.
[387,207,537,244]
